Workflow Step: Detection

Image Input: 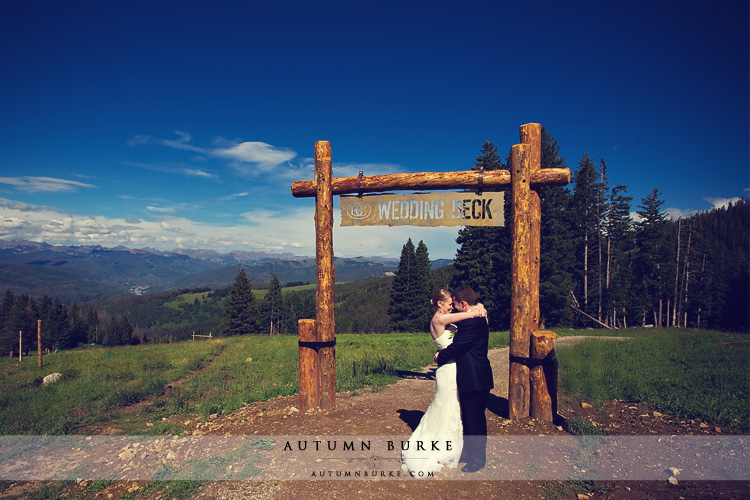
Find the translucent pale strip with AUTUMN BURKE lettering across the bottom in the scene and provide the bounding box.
[0,436,750,481]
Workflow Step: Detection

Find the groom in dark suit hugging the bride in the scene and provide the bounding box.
[435,286,494,472]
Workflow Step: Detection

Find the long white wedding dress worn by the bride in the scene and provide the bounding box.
[401,325,463,477]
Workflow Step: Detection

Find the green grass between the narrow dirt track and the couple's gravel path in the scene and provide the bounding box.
[170,332,508,418]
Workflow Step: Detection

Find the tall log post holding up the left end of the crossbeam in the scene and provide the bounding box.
[315,141,336,408]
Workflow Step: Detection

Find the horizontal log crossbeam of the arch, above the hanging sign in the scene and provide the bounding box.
[292,168,570,198]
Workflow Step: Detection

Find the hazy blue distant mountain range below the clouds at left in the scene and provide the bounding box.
[0,240,451,303]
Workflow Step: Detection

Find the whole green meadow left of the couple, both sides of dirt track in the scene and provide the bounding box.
[0,333,508,435]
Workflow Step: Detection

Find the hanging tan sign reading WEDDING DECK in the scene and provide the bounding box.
[341,191,504,227]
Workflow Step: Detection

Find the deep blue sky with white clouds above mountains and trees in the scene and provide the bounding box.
[0,0,750,258]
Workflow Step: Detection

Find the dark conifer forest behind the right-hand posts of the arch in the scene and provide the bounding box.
[453,129,750,332]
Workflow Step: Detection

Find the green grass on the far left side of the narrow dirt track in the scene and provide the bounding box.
[0,340,225,435]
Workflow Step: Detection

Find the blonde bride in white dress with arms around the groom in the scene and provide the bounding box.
[401,288,487,477]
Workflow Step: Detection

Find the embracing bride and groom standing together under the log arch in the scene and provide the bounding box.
[401,286,494,477]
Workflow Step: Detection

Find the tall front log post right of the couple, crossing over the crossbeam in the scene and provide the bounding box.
[508,144,531,420]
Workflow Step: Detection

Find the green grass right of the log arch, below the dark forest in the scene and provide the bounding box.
[557,329,750,428]
